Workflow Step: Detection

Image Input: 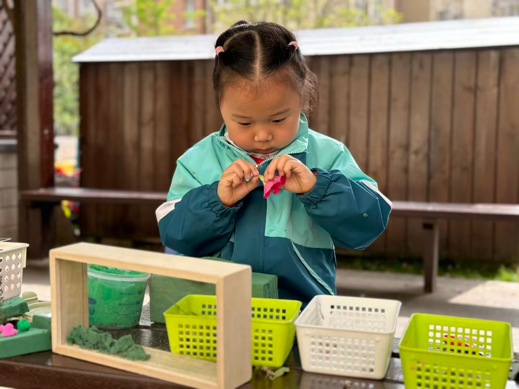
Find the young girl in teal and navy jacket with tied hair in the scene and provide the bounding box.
[157,22,391,304]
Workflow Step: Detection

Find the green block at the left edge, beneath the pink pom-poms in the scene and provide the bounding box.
[0,327,52,359]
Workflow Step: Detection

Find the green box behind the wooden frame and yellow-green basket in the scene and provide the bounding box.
[150,258,278,323]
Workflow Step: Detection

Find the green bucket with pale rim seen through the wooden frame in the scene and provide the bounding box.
[88,265,150,329]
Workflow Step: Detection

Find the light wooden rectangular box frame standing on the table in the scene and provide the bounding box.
[50,243,252,388]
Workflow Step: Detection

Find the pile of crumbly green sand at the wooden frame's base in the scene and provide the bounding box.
[67,326,150,361]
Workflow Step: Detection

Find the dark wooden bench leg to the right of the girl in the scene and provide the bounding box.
[423,220,440,293]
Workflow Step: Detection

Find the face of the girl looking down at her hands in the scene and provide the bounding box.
[220,78,301,154]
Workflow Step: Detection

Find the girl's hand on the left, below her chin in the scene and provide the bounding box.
[217,159,259,207]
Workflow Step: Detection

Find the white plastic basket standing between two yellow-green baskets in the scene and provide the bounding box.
[296,296,402,379]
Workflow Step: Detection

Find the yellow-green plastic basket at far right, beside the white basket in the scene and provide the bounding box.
[399,314,513,389]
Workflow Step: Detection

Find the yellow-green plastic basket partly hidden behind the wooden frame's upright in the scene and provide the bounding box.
[164,295,301,367]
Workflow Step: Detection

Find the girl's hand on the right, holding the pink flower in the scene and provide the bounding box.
[264,154,317,194]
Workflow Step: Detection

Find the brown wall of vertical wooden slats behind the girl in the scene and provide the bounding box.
[81,47,519,260]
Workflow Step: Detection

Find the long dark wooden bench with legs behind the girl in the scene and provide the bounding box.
[21,188,519,293]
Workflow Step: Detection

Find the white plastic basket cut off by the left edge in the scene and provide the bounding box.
[0,242,29,300]
